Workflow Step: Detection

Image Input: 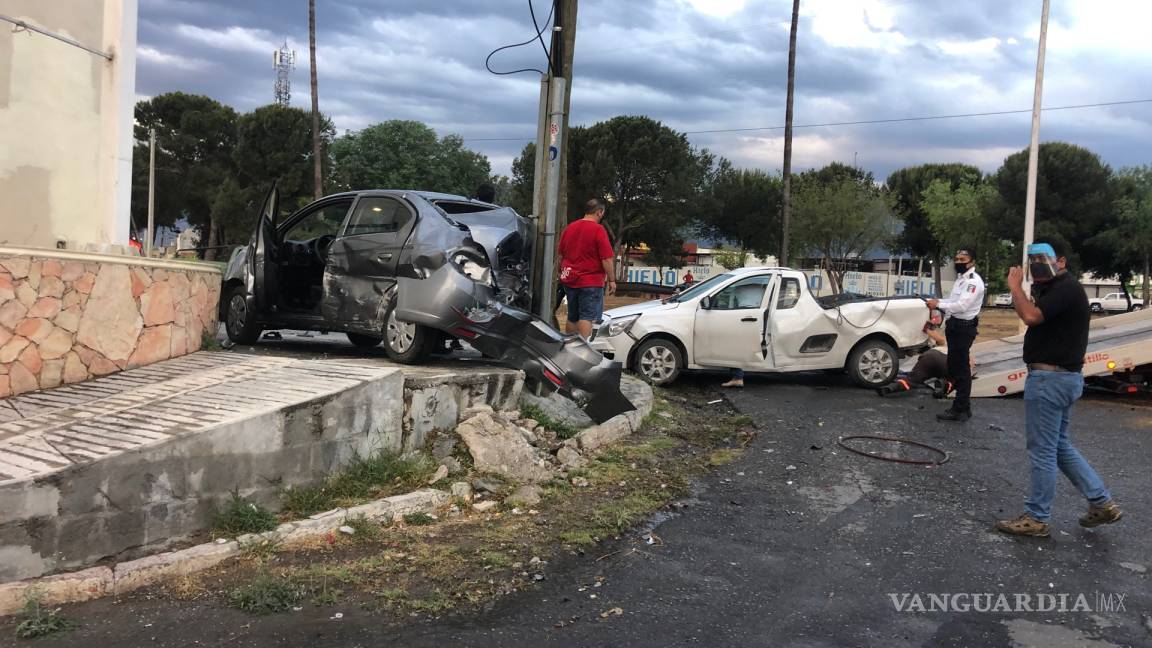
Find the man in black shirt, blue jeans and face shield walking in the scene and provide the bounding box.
[996,242,1123,537]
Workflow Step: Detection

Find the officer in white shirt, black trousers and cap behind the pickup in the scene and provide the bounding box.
[927,248,985,422]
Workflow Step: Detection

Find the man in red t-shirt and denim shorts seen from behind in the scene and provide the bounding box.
[560,198,616,339]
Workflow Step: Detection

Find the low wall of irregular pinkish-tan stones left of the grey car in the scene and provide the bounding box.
[0,248,220,398]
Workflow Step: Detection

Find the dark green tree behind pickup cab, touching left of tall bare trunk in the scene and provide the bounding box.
[699,160,782,257]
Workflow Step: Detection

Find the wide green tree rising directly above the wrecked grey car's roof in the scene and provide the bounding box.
[329,120,492,196]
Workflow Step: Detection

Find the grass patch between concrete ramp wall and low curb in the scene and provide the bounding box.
[281,452,437,518]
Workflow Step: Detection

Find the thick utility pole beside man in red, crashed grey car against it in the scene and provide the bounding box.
[533,0,577,322]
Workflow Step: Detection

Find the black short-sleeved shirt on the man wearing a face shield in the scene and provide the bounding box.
[1024,272,1092,371]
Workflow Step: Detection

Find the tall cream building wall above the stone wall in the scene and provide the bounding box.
[0,0,137,249]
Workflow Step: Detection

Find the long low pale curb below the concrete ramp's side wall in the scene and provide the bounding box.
[0,489,452,616]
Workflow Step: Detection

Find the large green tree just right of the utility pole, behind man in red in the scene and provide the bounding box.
[567,116,713,276]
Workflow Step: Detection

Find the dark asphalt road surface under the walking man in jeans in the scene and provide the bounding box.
[13,375,1152,648]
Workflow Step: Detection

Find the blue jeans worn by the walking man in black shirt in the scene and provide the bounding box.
[1024,371,1112,522]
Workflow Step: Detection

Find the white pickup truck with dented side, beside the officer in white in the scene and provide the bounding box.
[591,268,929,387]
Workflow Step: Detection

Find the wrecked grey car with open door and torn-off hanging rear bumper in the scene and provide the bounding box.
[220,188,632,422]
